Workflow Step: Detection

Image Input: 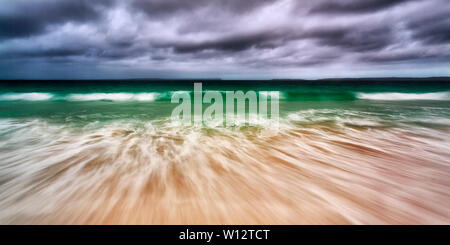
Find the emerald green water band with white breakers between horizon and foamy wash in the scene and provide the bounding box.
[0,80,450,125]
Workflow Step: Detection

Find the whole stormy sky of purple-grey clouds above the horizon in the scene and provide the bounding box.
[0,0,450,79]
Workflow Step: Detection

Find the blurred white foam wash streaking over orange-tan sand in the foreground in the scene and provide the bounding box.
[0,117,450,224]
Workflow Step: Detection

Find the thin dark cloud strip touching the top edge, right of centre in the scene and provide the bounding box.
[311,0,417,14]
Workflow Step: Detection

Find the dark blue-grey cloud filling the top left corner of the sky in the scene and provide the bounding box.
[0,0,112,39]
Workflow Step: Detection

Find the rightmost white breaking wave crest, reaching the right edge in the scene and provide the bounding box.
[357,92,450,100]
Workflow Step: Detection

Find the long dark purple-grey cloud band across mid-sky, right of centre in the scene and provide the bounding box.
[173,24,393,53]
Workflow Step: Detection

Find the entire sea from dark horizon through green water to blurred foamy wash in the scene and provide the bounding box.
[0,78,450,224]
